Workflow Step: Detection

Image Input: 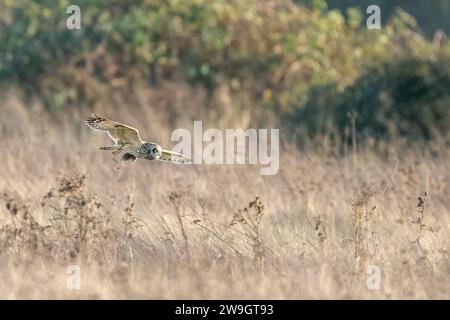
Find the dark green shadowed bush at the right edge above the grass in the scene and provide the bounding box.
[296,54,450,141]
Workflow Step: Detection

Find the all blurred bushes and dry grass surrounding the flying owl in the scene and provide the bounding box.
[0,0,450,299]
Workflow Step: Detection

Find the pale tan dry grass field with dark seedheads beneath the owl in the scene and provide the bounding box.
[0,90,450,299]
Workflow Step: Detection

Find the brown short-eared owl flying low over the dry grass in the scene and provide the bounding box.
[86,114,191,163]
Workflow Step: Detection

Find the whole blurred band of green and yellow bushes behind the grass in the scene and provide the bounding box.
[0,0,448,142]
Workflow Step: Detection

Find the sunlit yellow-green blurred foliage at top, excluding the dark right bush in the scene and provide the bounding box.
[0,0,398,101]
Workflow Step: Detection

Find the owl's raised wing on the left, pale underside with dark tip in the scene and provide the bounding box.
[86,114,143,145]
